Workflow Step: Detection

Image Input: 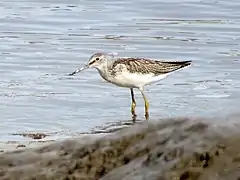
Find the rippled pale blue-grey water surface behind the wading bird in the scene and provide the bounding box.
[0,0,240,140]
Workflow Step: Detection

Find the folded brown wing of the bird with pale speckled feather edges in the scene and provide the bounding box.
[112,58,191,76]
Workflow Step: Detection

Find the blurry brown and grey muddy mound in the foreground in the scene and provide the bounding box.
[0,118,240,180]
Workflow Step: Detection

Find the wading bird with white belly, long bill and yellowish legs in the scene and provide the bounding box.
[68,52,192,120]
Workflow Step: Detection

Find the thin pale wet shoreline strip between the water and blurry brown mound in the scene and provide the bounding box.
[0,120,135,153]
